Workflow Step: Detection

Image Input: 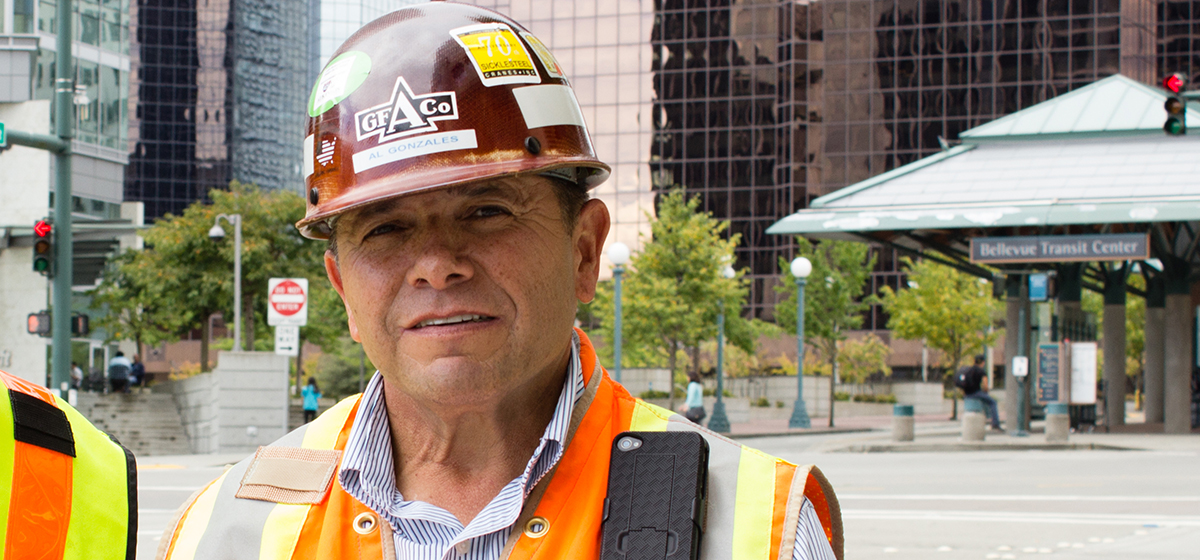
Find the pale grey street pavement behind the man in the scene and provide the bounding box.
[137,416,1200,560]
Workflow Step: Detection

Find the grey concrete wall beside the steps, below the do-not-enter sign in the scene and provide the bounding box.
[212,351,288,452]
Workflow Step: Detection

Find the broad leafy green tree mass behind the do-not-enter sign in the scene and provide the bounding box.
[94,181,346,371]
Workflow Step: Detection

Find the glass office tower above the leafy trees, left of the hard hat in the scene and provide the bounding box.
[125,0,311,218]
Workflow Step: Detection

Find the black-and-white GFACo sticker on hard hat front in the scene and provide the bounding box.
[354,77,458,141]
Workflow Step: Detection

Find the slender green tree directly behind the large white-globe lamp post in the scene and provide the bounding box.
[775,237,875,427]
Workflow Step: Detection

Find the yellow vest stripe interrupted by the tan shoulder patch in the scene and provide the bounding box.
[258,398,358,560]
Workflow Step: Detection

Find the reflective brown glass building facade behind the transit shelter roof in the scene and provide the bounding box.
[415,0,1200,329]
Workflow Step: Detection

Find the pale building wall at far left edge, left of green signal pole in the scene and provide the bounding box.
[0,101,50,385]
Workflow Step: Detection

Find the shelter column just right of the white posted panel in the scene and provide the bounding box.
[1102,263,1129,430]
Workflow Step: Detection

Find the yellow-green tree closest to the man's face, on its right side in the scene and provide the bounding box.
[588,188,754,407]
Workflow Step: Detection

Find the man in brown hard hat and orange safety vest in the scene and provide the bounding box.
[154,2,841,560]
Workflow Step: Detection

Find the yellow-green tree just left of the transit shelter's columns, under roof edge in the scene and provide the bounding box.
[881,258,997,372]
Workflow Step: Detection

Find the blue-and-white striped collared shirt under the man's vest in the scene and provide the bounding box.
[338,336,833,560]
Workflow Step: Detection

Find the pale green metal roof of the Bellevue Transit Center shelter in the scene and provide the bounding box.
[767,76,1200,236]
